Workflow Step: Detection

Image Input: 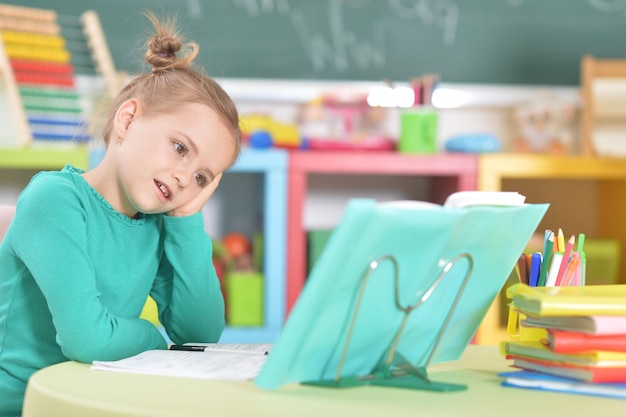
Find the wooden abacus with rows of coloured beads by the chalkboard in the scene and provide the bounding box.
[0,4,122,145]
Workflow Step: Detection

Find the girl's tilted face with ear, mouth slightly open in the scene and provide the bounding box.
[110,102,236,217]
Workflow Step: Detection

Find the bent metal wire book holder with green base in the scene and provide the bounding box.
[303,253,474,392]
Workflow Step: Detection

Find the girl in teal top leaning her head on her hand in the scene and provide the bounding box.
[0,14,241,416]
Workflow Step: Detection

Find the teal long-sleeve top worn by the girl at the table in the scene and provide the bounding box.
[0,165,224,416]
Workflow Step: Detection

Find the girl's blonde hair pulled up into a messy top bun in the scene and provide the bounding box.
[102,12,241,163]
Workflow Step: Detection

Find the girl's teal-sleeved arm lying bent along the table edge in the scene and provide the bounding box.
[11,177,167,362]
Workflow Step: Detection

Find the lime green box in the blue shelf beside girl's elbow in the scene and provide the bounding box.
[226,271,263,326]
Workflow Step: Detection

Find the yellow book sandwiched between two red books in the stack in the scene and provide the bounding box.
[500,341,626,367]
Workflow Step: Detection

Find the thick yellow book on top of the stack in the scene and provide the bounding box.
[507,284,626,317]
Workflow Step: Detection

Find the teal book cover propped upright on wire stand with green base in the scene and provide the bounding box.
[254,200,548,392]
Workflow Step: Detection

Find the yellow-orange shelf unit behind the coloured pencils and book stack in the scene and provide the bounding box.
[476,154,626,344]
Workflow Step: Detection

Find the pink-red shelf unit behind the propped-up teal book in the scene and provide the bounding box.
[286,151,477,312]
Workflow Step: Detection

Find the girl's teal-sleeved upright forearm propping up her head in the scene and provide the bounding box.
[151,213,225,344]
